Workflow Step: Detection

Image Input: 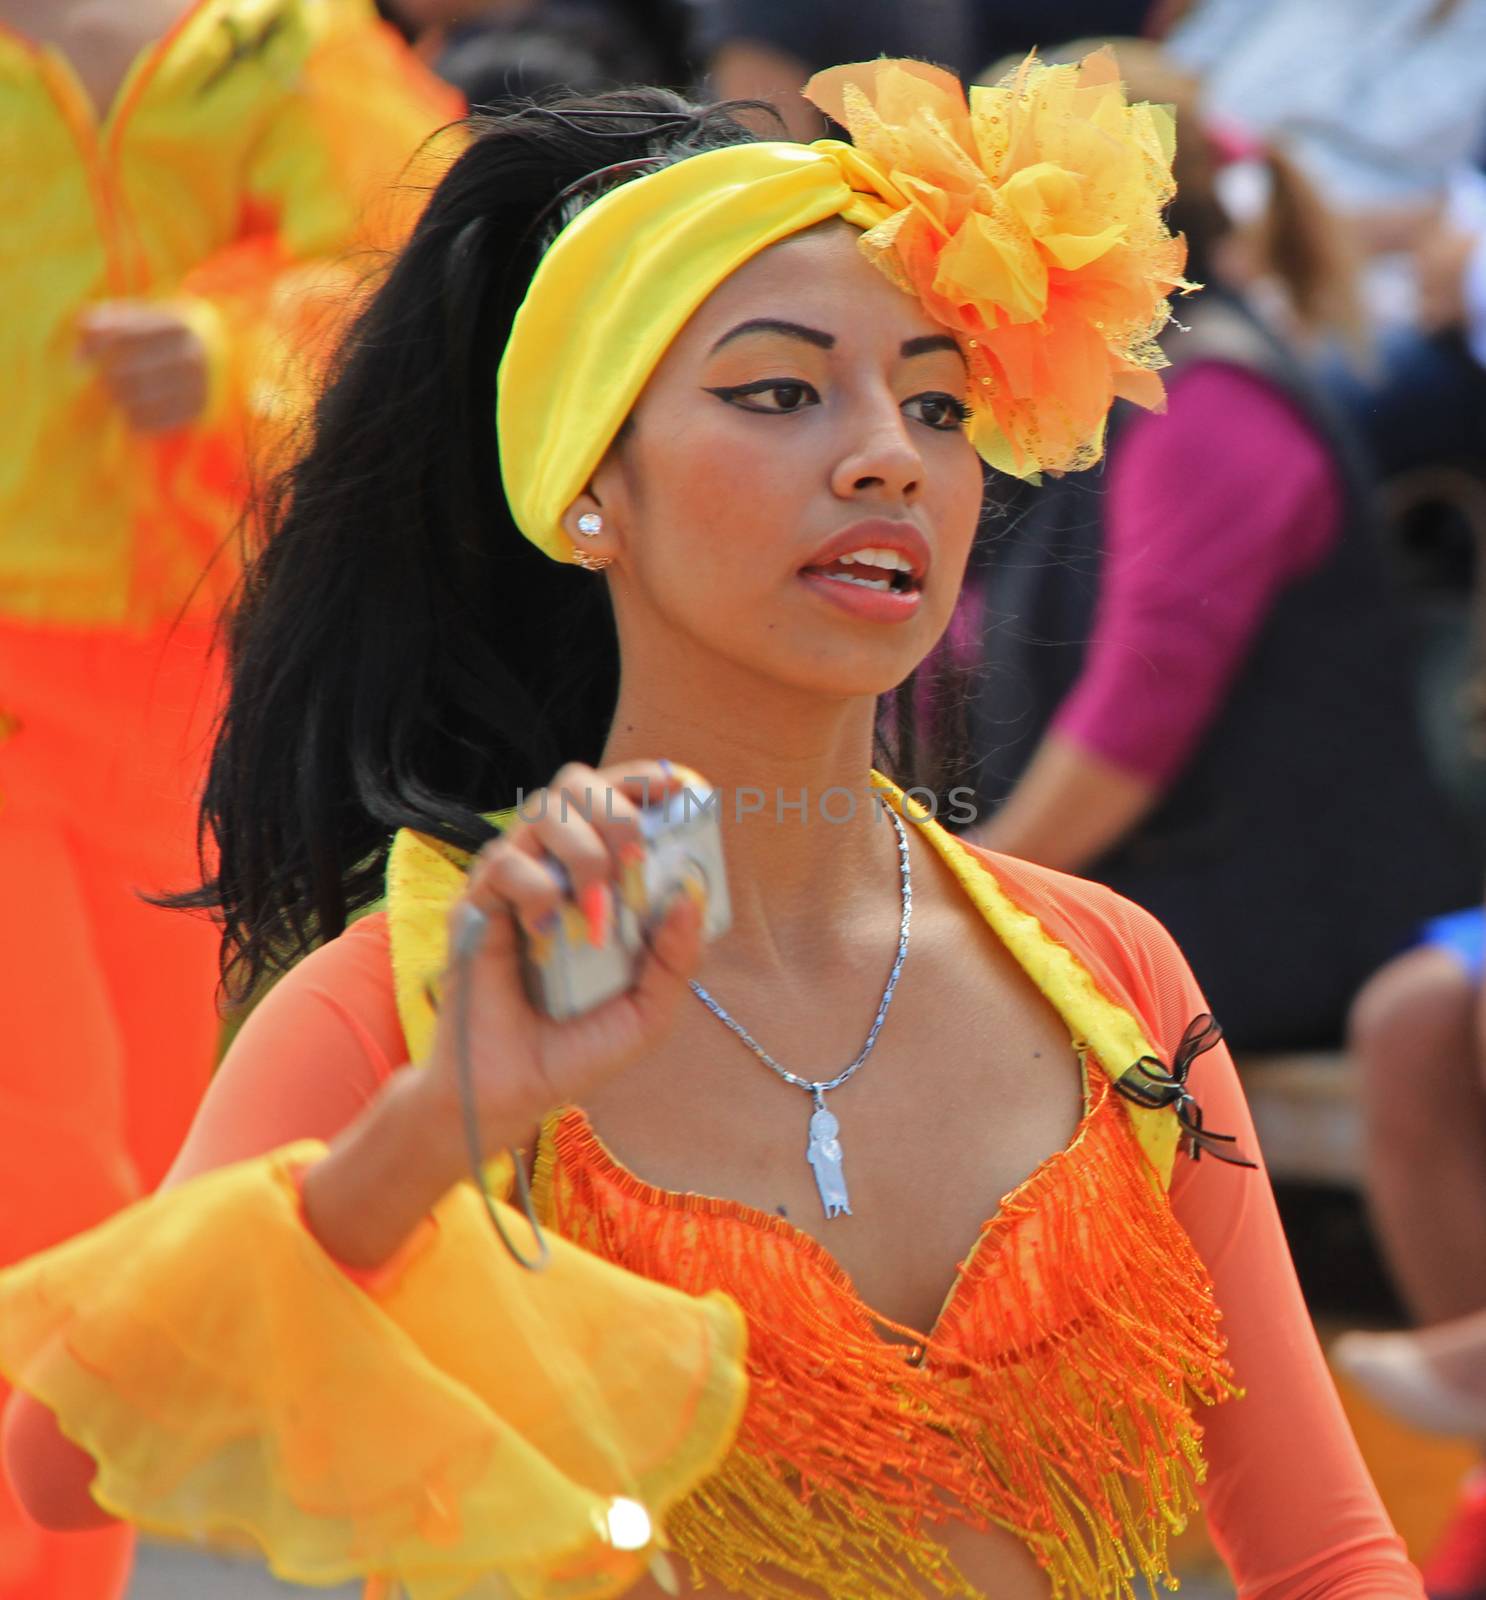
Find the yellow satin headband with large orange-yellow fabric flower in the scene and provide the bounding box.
[496,50,1192,562]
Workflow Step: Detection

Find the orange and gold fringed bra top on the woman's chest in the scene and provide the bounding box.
[536,1074,1238,1600]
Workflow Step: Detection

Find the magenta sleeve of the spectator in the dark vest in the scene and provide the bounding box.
[1053,358,1345,792]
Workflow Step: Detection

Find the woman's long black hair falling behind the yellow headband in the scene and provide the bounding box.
[171,90,959,995]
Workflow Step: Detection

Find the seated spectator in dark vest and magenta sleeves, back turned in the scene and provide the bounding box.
[965,42,1475,1048]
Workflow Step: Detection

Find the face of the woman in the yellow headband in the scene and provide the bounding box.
[574,224,982,696]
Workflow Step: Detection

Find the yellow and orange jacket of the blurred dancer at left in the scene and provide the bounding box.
[0,0,462,627]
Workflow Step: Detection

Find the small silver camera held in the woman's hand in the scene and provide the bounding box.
[520,784,733,1021]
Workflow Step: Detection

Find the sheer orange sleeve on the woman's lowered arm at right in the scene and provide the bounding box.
[993,856,1424,1600]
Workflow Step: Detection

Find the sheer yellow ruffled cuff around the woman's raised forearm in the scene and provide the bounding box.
[0,1141,745,1600]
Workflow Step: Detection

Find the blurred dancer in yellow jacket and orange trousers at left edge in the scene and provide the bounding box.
[0,0,462,1600]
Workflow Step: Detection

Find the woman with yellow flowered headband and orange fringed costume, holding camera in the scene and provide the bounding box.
[0,56,1420,1600]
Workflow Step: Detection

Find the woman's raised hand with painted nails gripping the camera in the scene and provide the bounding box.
[419,762,702,1171]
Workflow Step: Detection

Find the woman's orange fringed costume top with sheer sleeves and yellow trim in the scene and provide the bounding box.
[13,793,1422,1600]
